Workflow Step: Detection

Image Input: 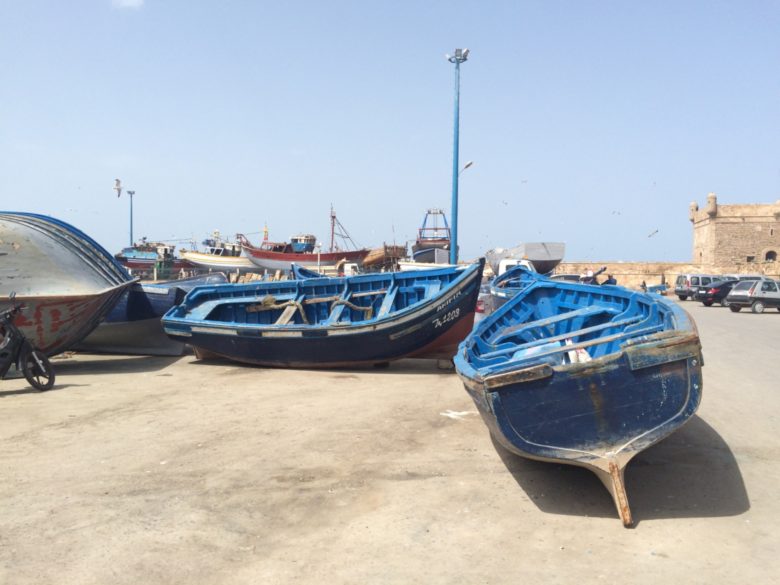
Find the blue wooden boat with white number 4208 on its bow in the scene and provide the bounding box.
[163,260,484,368]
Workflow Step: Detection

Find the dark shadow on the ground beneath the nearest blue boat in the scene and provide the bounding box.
[491,416,750,525]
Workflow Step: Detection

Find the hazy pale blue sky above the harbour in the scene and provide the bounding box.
[0,0,780,261]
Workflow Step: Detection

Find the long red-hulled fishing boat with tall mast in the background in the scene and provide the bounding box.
[238,208,369,271]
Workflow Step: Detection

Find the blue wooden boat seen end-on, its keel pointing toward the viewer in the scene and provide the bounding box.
[455,273,702,526]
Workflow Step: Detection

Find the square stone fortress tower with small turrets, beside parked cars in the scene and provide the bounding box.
[688,193,780,273]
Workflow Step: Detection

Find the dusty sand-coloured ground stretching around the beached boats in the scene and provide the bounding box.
[0,301,780,585]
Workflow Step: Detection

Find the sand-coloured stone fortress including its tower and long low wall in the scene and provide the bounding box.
[555,193,780,288]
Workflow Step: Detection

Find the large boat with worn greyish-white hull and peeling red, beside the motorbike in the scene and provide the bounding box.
[0,211,135,355]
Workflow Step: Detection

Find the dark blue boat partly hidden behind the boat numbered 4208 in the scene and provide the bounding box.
[76,272,228,356]
